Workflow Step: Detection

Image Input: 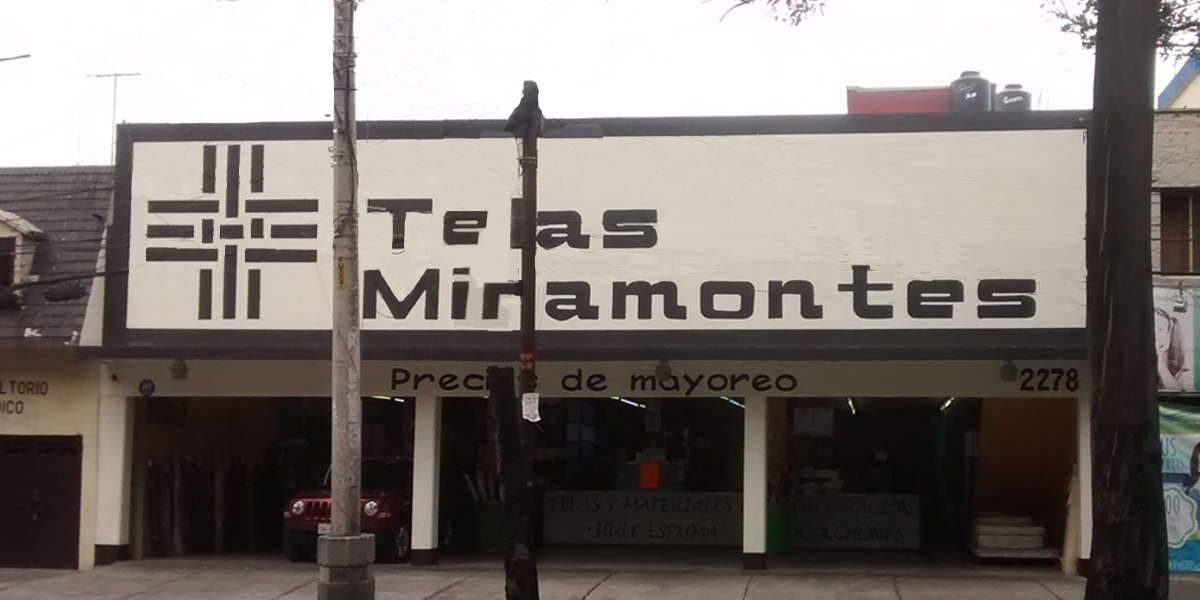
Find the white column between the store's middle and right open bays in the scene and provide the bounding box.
[742,397,767,570]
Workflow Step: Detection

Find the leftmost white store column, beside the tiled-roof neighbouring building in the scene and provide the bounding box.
[96,367,133,565]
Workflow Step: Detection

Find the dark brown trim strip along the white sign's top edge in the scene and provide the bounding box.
[128,110,1091,142]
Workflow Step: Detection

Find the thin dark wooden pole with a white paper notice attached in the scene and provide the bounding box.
[487,82,541,600]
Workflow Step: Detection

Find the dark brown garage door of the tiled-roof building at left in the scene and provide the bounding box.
[0,436,83,569]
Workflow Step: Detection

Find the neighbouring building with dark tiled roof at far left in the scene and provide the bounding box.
[0,167,113,569]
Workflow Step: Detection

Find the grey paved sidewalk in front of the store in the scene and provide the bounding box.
[0,558,1200,600]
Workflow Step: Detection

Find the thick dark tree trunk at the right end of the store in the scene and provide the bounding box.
[1087,0,1168,600]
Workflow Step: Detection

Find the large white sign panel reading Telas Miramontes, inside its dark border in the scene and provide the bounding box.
[126,130,1085,330]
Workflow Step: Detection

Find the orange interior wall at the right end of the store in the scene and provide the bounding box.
[974,398,1076,546]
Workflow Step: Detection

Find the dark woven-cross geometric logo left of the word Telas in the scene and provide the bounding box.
[146,144,319,320]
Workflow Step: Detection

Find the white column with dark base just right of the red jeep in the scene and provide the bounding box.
[413,394,442,565]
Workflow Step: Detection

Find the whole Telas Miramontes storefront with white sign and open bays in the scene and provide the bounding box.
[84,113,1090,568]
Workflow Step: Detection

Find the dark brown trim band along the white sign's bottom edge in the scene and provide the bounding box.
[80,329,1087,361]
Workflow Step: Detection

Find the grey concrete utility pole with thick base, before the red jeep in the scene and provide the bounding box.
[317,0,374,600]
